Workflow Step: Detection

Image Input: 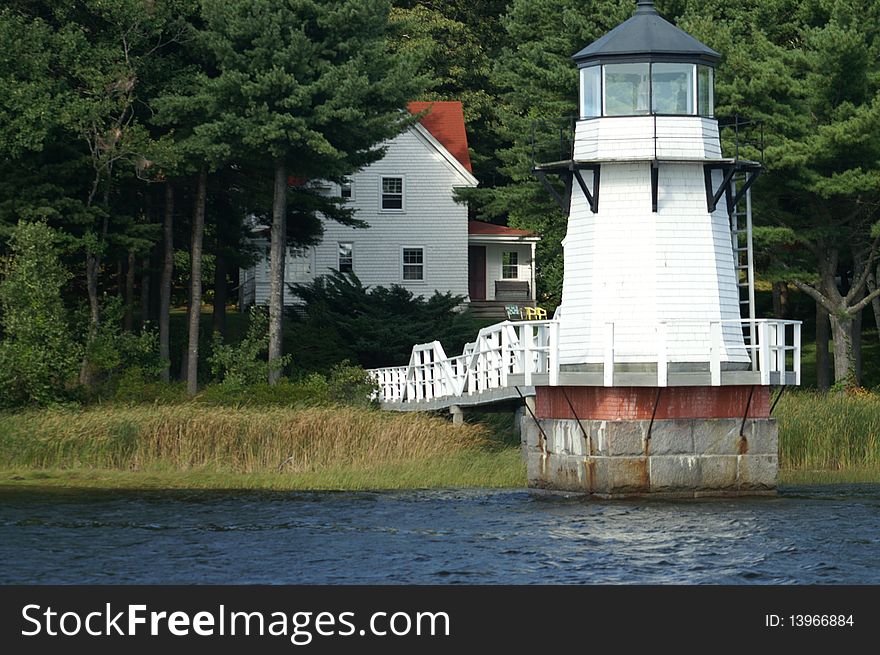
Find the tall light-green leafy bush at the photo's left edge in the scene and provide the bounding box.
[0,222,82,407]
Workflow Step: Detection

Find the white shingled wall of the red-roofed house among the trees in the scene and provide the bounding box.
[241,126,475,304]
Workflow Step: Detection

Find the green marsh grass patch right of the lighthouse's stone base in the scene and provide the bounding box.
[774,391,880,480]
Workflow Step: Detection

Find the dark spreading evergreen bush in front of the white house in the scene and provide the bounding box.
[288,272,475,371]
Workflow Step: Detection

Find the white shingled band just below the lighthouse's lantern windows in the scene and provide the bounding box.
[574,116,721,161]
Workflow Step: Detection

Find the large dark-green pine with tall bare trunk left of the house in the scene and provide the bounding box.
[203,0,423,383]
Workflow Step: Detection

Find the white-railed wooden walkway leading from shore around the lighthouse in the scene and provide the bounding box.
[369,319,801,411]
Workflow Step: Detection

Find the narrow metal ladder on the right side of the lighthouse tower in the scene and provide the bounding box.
[730,173,758,367]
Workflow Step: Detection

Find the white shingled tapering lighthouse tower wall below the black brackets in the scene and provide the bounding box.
[559,162,747,364]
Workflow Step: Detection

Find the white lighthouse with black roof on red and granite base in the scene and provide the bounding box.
[522,0,800,497]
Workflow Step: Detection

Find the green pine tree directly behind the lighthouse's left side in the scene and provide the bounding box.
[478,0,635,306]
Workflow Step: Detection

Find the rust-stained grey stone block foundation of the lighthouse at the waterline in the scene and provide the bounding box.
[521,413,777,498]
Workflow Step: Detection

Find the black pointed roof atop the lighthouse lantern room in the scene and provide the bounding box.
[572,0,721,66]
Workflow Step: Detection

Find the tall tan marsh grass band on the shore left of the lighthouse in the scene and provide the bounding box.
[0,404,501,474]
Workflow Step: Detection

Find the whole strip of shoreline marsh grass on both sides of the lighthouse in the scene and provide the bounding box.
[0,391,880,490]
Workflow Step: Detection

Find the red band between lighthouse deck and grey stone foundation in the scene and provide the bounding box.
[535,386,770,421]
